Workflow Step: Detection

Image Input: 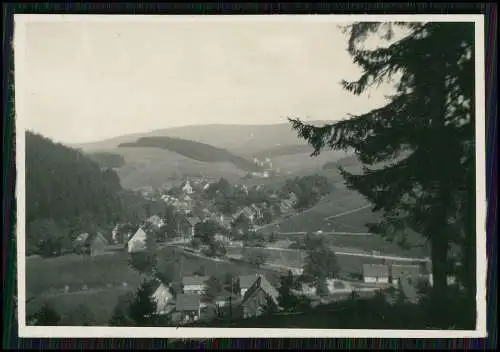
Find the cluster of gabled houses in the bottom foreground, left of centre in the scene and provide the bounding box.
[148,274,278,324]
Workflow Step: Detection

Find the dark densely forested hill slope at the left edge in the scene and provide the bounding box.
[26,132,127,255]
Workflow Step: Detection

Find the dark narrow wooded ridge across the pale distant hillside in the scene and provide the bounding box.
[119,137,258,171]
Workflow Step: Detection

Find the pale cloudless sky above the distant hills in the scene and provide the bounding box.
[14,20,388,143]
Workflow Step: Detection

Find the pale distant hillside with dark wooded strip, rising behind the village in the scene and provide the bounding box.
[73,122,356,189]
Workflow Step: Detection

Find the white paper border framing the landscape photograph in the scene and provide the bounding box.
[13,14,488,339]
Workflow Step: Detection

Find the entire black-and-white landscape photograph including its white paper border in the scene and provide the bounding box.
[13,15,487,338]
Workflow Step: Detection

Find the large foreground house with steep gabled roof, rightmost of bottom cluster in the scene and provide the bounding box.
[241,275,279,318]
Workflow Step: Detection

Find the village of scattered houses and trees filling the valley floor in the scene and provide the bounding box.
[64,178,444,324]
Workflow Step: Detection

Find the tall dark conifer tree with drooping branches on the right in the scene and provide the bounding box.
[290,22,475,320]
